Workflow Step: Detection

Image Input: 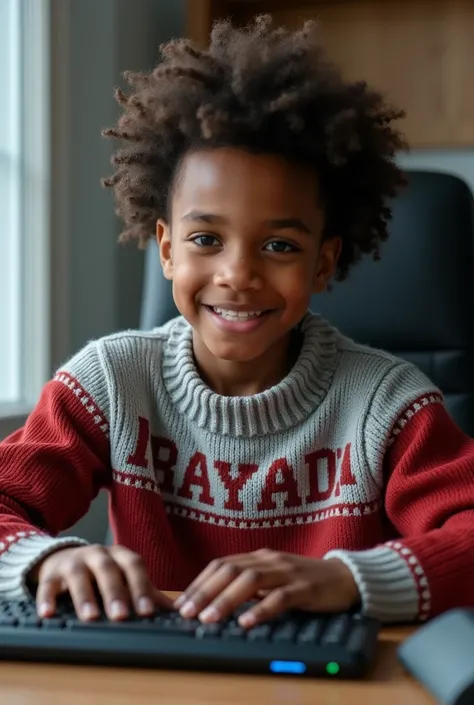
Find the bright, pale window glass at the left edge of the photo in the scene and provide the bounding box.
[0,0,50,438]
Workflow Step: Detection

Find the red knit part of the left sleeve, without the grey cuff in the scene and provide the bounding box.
[0,374,111,540]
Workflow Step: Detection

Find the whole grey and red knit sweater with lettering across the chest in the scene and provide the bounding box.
[0,313,474,622]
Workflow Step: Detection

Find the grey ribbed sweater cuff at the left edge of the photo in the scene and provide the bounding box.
[0,531,87,600]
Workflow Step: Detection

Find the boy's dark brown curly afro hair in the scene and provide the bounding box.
[102,15,406,280]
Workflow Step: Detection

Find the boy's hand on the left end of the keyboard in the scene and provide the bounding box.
[31,545,172,620]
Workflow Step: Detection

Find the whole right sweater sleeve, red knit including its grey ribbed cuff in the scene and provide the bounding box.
[326,384,474,622]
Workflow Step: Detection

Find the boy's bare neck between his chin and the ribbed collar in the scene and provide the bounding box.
[193,333,301,397]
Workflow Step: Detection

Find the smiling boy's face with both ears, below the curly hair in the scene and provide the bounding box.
[157,148,340,363]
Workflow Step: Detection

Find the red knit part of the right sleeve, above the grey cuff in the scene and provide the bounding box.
[385,403,474,618]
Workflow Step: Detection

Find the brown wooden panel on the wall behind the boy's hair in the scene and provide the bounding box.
[190,0,474,147]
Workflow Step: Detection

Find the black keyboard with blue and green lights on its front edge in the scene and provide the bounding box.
[0,600,379,678]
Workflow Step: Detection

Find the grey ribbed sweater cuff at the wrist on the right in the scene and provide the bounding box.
[324,545,420,623]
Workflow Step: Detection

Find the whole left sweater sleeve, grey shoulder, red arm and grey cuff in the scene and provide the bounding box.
[0,343,111,598]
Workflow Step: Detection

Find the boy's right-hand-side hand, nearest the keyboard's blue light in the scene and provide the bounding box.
[174,549,360,627]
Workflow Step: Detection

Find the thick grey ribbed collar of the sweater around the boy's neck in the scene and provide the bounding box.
[162,313,338,438]
